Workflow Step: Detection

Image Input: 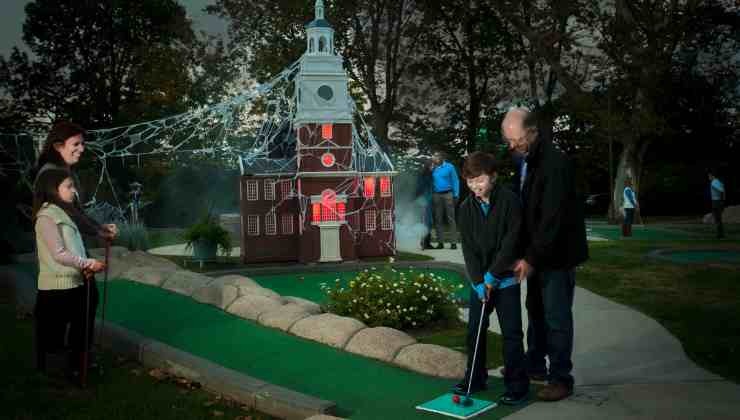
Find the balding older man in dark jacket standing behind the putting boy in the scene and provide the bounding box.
[501,108,588,401]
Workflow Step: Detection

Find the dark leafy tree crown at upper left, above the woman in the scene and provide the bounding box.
[0,0,217,128]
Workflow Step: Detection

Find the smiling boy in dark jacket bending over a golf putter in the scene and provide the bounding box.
[454,152,529,405]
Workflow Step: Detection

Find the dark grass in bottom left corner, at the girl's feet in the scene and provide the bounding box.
[0,303,273,420]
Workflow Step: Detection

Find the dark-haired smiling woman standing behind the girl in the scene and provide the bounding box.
[34,121,118,374]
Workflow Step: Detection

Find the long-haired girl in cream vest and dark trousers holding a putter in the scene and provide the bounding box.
[33,168,105,380]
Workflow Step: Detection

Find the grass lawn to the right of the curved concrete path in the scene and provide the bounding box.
[577,238,740,382]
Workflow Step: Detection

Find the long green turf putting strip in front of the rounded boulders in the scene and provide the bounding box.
[107,280,528,419]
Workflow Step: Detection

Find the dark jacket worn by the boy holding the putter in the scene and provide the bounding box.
[457,184,522,284]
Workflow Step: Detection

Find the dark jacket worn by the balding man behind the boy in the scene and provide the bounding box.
[521,133,588,270]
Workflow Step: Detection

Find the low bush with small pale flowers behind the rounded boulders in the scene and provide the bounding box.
[321,267,464,330]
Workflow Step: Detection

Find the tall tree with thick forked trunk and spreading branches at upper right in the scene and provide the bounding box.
[497,0,740,220]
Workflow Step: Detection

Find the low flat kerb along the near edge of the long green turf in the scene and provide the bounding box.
[96,320,336,420]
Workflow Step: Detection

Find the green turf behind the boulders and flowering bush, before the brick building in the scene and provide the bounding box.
[249,266,470,304]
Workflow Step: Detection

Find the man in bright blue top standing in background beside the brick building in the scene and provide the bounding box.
[432,152,460,249]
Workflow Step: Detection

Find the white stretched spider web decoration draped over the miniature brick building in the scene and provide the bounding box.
[0,54,395,256]
